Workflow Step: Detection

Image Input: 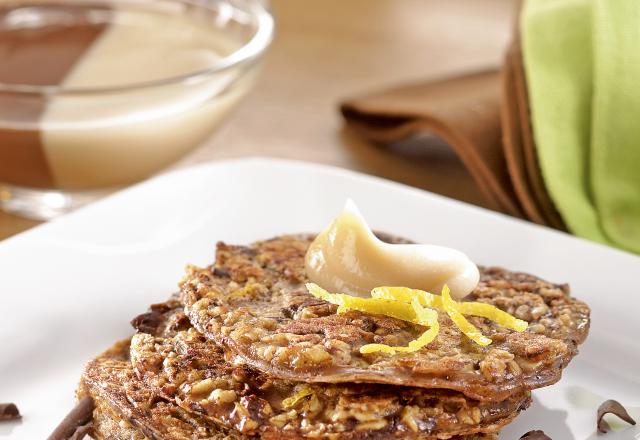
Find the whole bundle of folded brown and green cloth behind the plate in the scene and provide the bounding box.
[341,0,640,253]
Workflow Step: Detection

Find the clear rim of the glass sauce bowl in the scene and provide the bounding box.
[0,0,275,96]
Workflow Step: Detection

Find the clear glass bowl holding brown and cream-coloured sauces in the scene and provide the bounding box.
[0,0,273,219]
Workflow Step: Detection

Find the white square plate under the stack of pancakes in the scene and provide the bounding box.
[0,159,640,440]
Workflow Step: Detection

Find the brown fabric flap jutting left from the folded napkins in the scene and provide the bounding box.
[341,71,524,217]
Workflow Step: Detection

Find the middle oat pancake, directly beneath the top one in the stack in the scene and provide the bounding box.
[131,304,530,440]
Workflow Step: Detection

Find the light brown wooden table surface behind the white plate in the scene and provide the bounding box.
[0,0,515,239]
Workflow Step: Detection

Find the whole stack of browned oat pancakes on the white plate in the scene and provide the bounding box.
[79,236,589,440]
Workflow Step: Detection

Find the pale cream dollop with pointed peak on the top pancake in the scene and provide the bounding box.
[305,200,480,300]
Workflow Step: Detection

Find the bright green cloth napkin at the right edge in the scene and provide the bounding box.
[520,0,640,253]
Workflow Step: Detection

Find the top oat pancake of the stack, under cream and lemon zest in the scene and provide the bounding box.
[181,236,590,401]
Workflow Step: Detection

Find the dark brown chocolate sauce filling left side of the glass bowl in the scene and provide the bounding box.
[0,3,106,188]
